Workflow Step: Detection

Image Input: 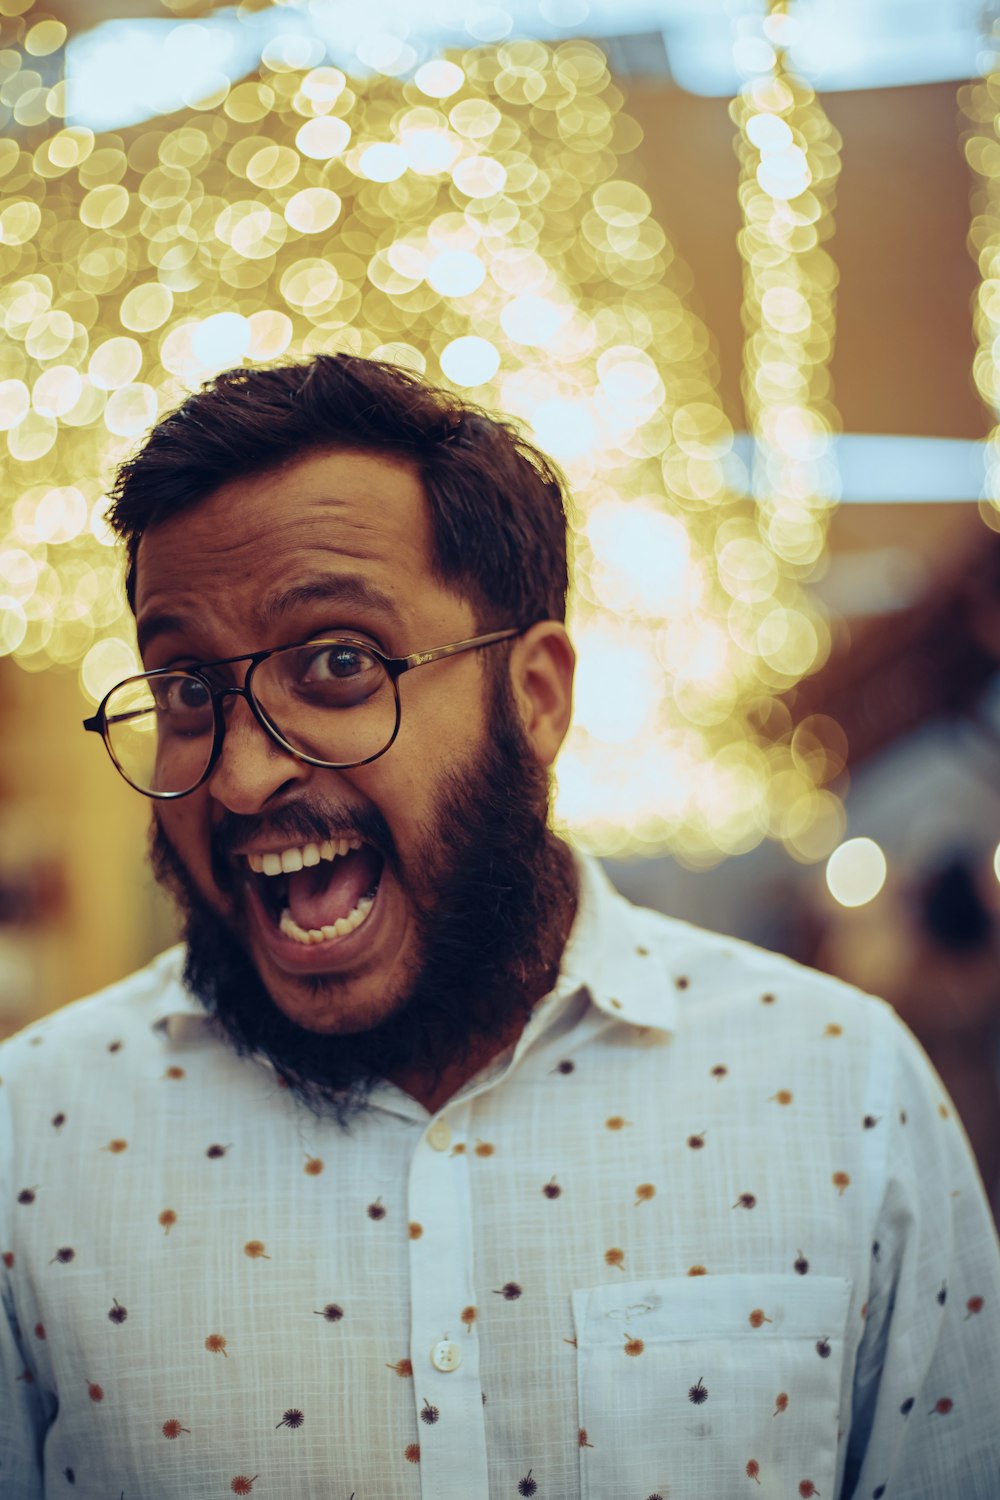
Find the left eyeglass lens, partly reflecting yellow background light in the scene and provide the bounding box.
[105,672,214,797]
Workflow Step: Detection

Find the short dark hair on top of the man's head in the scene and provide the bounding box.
[108,354,567,630]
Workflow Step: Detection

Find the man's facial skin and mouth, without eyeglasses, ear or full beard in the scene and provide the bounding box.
[136,438,520,1032]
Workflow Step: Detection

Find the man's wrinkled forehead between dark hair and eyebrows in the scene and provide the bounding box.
[135,450,444,645]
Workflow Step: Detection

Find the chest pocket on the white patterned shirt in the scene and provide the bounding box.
[573,1275,852,1500]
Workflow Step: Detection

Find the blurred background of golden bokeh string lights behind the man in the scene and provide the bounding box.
[0,0,1000,1205]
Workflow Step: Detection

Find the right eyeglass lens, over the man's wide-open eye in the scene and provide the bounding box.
[250,639,397,765]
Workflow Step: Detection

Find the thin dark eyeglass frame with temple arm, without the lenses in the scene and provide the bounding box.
[82,626,528,803]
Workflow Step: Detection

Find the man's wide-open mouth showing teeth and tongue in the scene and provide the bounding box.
[246,839,382,947]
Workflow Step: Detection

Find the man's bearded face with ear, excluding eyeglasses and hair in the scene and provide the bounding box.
[136,438,574,1098]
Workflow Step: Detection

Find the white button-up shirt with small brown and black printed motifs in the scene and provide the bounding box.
[0,861,1000,1500]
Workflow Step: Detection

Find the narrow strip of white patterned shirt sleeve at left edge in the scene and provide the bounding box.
[0,1088,45,1500]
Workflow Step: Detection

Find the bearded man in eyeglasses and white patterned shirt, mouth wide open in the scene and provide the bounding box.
[0,357,1000,1500]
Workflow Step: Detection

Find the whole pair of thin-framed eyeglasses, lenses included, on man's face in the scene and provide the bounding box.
[84,630,523,798]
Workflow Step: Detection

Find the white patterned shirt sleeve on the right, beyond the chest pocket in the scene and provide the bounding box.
[843,1008,1000,1500]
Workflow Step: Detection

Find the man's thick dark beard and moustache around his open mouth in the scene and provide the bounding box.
[151,674,576,1127]
